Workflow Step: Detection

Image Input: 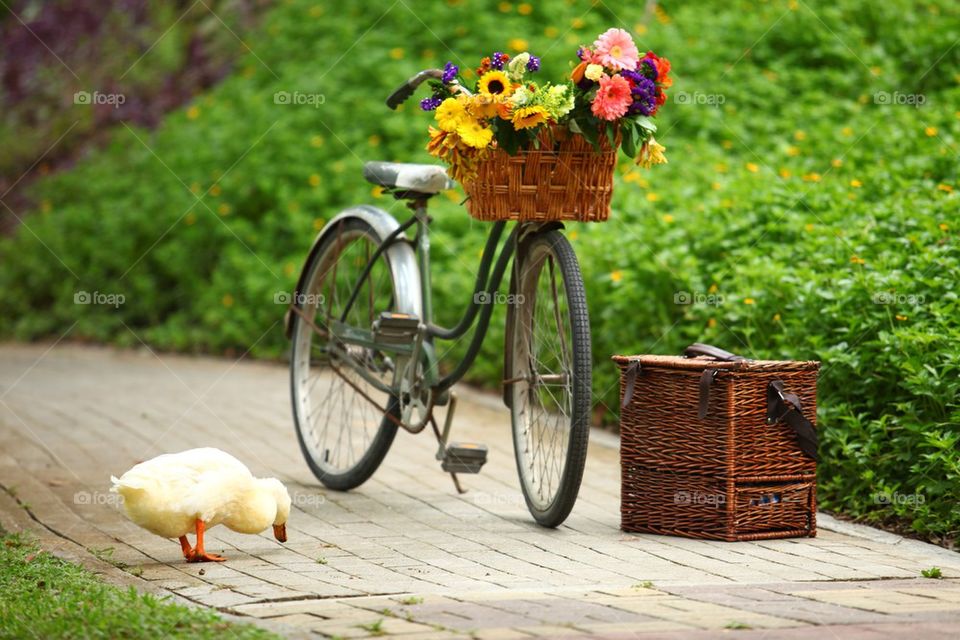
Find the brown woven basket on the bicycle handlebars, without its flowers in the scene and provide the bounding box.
[464,126,620,222]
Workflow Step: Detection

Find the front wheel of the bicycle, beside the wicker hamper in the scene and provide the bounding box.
[507,231,591,527]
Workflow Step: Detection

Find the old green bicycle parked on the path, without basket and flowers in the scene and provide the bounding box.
[285,69,591,527]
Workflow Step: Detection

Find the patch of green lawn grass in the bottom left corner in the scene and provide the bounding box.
[0,534,277,640]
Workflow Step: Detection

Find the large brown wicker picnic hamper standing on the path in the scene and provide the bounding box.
[613,345,820,541]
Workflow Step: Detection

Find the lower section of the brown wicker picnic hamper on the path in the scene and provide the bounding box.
[620,465,816,542]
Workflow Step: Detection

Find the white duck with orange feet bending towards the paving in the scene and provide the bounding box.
[110,448,291,562]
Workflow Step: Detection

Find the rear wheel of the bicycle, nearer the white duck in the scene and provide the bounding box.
[290,217,410,491]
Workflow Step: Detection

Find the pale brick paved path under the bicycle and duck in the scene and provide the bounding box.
[0,344,960,639]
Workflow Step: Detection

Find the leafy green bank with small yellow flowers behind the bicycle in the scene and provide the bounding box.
[0,0,960,539]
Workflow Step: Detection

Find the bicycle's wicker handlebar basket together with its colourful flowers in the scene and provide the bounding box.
[420,29,672,221]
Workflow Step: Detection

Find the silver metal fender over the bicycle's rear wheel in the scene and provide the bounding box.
[283,205,423,339]
